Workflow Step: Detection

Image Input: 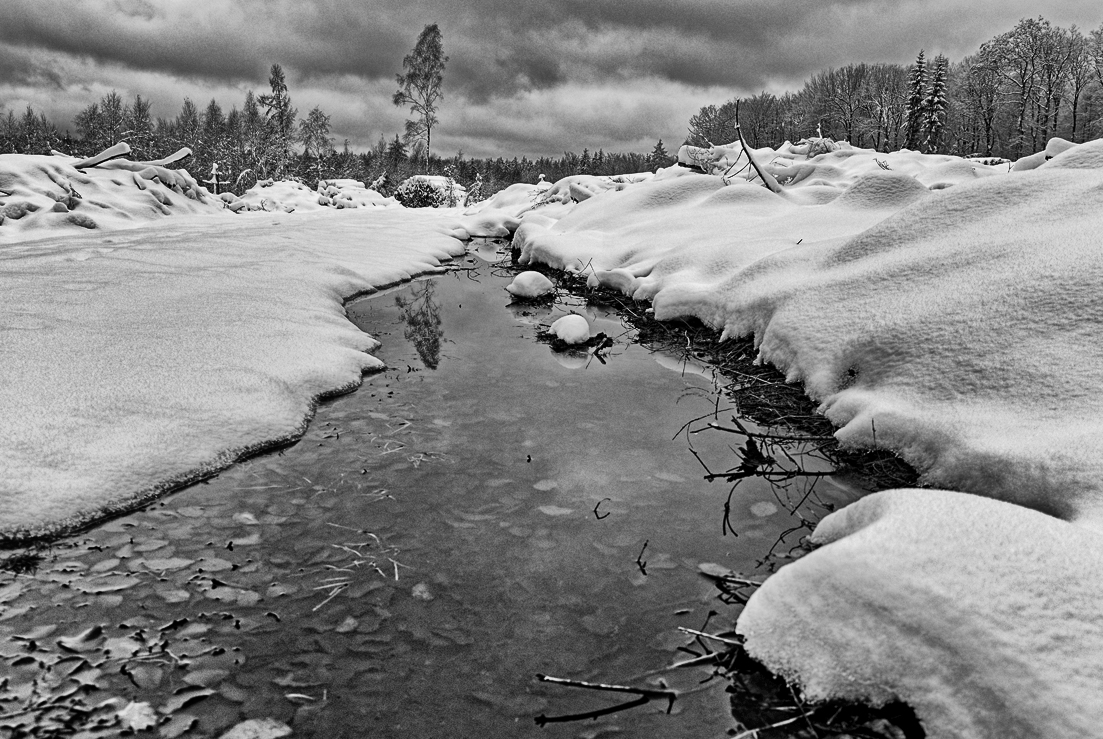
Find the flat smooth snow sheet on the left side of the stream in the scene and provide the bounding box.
[0,208,463,534]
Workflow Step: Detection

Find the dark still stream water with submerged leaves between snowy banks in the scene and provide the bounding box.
[0,250,843,738]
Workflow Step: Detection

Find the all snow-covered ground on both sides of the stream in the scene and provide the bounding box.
[0,141,1103,737]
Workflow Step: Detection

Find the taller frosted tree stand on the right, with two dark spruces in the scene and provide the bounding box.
[686,17,1103,159]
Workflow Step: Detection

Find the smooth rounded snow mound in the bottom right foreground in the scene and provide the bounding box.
[737,490,1103,739]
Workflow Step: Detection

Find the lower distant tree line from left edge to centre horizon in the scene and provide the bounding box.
[0,76,674,196]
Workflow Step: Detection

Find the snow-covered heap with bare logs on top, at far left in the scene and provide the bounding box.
[0,154,223,244]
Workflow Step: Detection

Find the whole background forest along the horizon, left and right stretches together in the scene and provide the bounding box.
[0,18,1103,199]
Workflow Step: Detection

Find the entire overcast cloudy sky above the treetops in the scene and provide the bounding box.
[0,0,1103,158]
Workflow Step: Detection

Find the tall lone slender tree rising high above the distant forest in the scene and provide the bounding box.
[392,23,448,168]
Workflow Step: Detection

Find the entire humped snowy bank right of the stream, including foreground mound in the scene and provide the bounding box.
[459,141,1103,737]
